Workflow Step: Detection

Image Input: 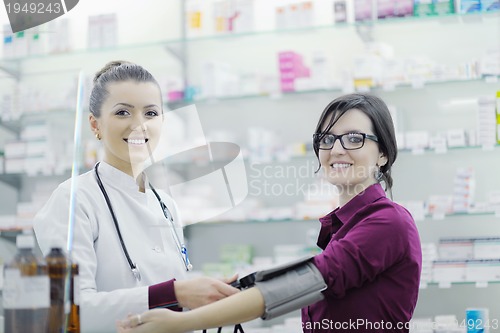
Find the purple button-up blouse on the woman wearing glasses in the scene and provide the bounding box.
[302,184,422,333]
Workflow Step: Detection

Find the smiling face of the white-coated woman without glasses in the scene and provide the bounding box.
[89,81,163,176]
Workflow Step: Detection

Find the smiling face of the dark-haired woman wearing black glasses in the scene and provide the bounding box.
[319,109,387,205]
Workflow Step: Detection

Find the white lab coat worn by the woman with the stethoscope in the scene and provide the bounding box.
[34,162,186,333]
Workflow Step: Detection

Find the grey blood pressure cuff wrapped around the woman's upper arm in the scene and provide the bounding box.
[255,257,327,320]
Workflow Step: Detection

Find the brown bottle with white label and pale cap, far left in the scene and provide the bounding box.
[3,234,50,333]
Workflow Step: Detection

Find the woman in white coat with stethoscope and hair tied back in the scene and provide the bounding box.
[34,61,238,333]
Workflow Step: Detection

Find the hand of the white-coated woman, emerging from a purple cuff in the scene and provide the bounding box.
[174,275,239,309]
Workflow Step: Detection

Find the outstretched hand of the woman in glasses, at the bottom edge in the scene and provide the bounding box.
[116,309,182,333]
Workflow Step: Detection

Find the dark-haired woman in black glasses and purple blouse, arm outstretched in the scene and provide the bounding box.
[118,94,422,333]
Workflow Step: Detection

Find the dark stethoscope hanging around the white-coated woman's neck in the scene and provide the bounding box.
[94,163,193,281]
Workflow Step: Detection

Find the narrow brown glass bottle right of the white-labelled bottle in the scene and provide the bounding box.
[45,247,68,333]
